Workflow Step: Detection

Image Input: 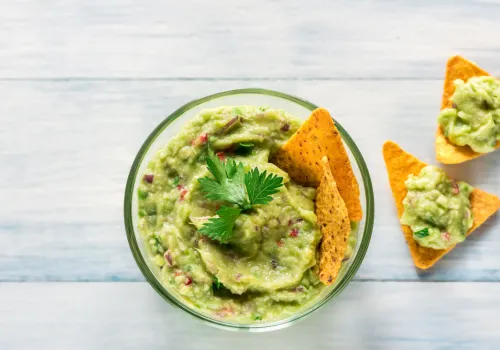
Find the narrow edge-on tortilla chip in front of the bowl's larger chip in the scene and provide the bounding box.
[316,157,351,285]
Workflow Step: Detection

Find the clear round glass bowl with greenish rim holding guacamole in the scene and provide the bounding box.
[124,89,374,332]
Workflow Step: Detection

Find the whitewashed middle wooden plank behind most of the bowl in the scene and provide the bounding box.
[0,80,500,281]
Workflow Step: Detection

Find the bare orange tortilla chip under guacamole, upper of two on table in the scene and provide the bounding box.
[436,56,500,164]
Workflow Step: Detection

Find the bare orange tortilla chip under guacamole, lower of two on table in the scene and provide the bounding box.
[383,141,500,269]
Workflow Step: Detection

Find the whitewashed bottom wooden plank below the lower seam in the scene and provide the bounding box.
[0,282,500,350]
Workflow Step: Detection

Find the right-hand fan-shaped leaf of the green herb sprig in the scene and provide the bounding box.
[245,168,283,205]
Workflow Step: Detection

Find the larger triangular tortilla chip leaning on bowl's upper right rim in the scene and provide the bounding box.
[273,108,363,221]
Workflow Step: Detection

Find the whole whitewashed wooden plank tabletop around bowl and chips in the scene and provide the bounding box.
[0,0,500,350]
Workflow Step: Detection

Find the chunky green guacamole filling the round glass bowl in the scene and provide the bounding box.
[137,106,357,323]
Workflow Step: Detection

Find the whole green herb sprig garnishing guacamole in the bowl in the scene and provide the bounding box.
[198,146,283,243]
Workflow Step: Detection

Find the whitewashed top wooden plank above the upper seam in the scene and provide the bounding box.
[0,0,500,79]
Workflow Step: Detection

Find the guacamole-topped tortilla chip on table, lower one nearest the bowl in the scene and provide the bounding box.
[383,141,500,269]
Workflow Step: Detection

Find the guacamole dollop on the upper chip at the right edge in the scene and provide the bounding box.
[438,76,500,153]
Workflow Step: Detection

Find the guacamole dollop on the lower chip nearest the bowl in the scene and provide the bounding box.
[401,165,474,249]
